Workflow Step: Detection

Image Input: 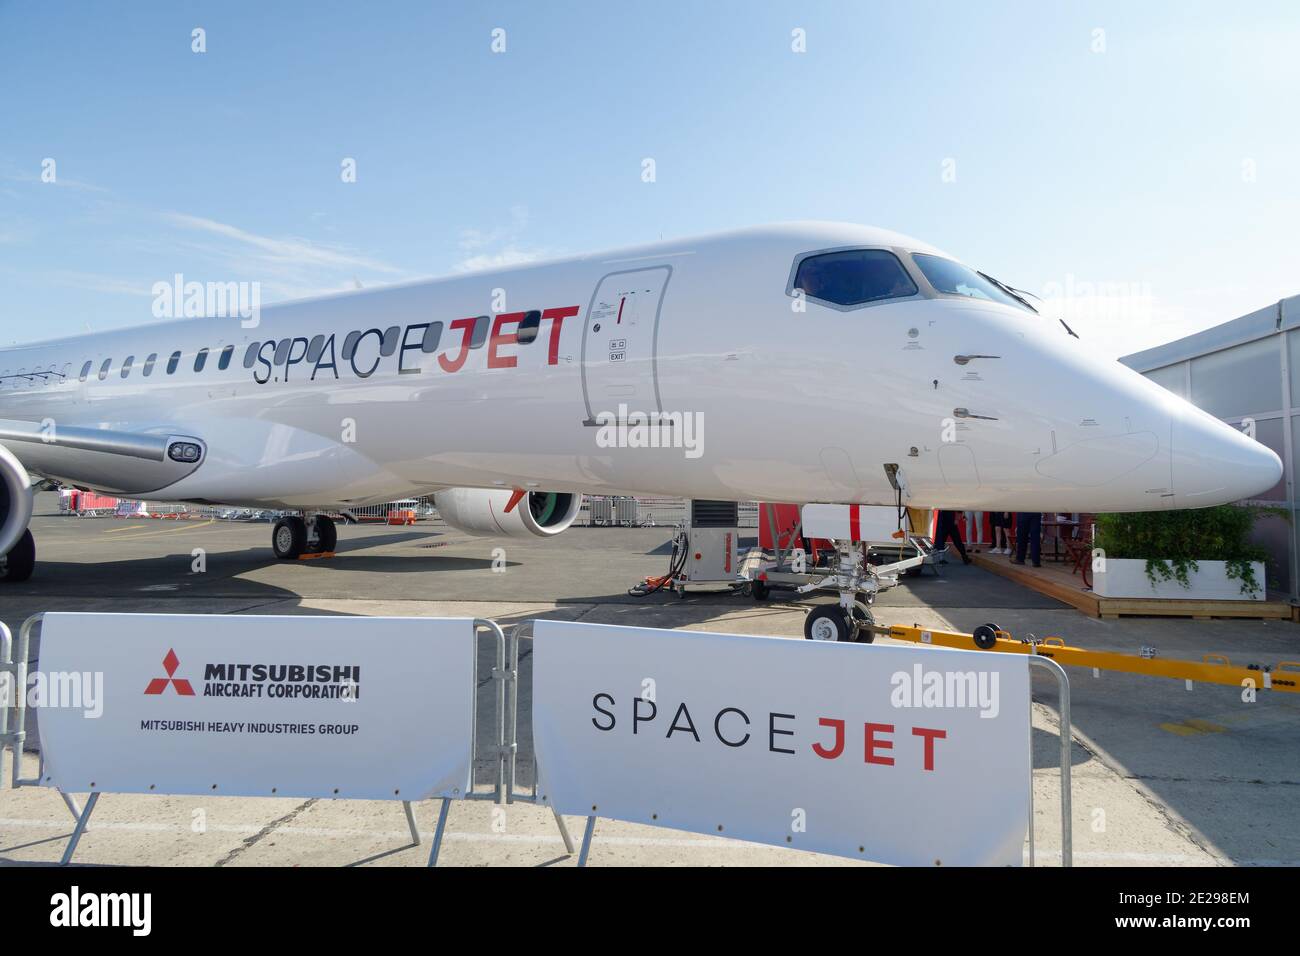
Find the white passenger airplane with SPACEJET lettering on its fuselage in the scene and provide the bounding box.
[0,222,1282,639]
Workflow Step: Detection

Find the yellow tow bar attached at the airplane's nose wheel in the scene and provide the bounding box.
[872,624,1300,693]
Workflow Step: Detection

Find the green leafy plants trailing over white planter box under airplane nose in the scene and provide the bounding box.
[1095,505,1290,596]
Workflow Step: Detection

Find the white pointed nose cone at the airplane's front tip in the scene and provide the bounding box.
[1171,410,1282,507]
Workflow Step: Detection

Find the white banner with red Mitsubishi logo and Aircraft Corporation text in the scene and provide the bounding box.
[33,614,475,800]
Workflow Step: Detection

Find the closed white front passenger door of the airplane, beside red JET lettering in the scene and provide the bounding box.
[582,265,672,425]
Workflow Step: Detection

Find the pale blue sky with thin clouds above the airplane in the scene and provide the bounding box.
[0,0,1300,354]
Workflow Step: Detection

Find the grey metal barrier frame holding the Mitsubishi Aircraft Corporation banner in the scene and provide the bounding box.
[0,611,517,866]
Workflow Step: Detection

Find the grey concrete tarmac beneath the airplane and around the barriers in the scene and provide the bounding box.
[0,494,1300,866]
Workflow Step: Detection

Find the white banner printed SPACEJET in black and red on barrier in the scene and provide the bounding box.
[533,620,1030,866]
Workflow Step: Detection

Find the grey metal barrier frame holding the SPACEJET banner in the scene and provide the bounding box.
[506,620,1074,866]
